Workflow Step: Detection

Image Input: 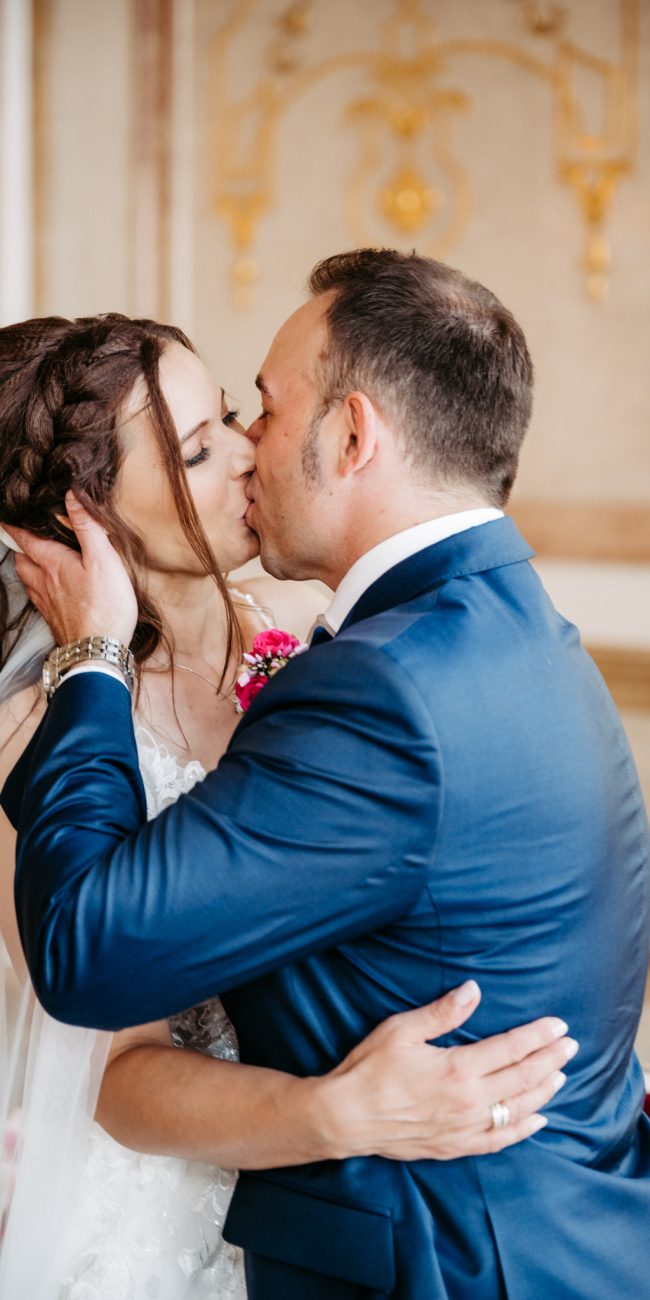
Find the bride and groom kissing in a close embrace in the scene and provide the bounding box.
[0,250,650,1300]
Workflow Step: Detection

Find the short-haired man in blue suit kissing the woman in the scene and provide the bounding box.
[5,250,650,1300]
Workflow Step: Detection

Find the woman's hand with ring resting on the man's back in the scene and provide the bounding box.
[319,980,577,1160]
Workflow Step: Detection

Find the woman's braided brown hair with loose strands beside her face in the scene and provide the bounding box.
[0,312,242,685]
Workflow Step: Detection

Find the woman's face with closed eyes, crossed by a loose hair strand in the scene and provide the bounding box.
[113,343,259,573]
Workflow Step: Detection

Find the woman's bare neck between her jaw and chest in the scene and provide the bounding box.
[147,572,228,663]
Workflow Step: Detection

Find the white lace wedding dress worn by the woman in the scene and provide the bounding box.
[54,727,246,1300]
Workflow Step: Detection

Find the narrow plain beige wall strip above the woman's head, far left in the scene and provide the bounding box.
[28,0,137,316]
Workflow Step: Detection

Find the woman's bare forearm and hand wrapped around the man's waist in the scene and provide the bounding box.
[96,984,572,1169]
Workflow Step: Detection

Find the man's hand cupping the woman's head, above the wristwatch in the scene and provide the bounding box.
[5,493,138,646]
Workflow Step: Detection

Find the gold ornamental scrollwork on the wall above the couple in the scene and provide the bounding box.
[211,0,638,307]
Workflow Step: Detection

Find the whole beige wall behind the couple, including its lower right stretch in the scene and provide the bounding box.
[3,0,650,772]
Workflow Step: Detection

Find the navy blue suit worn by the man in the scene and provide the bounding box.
[5,519,650,1300]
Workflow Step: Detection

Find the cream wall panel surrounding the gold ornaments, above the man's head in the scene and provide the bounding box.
[191,0,650,517]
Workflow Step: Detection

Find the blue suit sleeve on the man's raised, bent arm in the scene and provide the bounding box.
[16,641,439,1028]
